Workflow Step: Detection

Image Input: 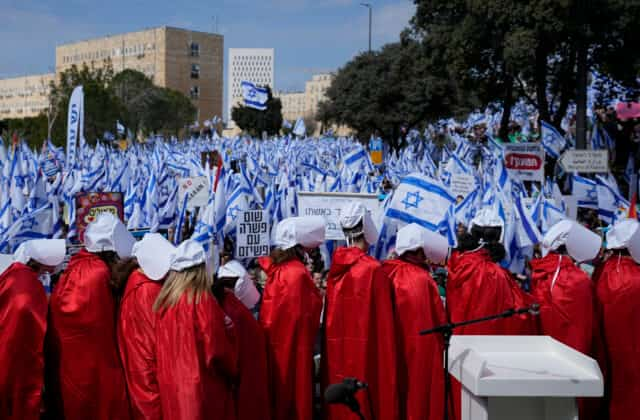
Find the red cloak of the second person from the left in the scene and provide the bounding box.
[47,249,130,420]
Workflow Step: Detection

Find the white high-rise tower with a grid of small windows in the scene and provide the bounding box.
[227,48,275,127]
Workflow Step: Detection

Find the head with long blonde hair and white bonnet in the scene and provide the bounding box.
[153,240,213,311]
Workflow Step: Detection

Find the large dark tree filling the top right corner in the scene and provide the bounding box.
[411,0,640,138]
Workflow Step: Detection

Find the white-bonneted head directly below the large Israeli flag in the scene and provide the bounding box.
[395,223,449,265]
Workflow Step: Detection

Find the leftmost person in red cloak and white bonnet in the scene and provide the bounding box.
[0,239,66,420]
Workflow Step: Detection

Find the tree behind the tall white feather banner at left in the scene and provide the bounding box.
[50,64,121,145]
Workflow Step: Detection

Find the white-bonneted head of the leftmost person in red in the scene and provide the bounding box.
[14,239,67,275]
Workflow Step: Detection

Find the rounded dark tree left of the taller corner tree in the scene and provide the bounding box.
[316,37,459,147]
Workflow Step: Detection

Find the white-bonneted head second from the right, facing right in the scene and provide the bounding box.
[540,220,602,262]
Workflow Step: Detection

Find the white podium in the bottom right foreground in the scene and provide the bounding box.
[449,335,603,420]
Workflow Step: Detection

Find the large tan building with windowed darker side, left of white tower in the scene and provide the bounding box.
[56,26,224,123]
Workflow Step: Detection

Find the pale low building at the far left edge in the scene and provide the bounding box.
[0,73,55,120]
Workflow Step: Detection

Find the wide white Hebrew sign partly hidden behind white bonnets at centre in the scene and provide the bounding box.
[298,192,382,241]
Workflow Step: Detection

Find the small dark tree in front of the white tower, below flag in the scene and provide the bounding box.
[231,86,282,137]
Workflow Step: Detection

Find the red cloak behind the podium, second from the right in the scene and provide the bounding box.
[531,253,594,355]
